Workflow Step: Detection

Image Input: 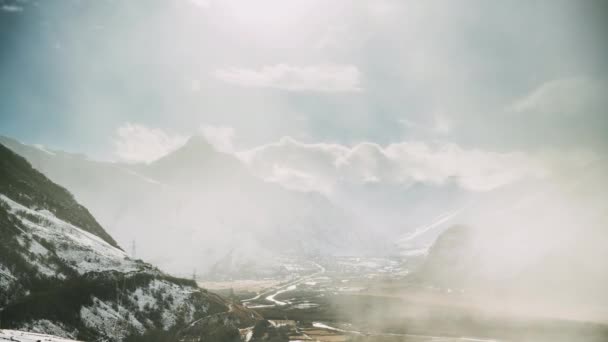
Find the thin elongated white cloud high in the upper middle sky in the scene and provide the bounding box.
[214,64,361,92]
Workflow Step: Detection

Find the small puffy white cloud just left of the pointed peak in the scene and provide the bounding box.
[114,122,188,162]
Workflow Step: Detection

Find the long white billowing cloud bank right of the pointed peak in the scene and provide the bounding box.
[239,137,546,194]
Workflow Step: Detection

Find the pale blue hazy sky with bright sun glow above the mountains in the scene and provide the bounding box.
[0,0,608,180]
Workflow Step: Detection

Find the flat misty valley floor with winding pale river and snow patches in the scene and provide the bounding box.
[200,258,608,342]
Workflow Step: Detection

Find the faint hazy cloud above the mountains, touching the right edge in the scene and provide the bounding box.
[512,77,608,116]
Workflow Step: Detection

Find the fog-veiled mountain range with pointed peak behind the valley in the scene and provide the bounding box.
[0,136,469,277]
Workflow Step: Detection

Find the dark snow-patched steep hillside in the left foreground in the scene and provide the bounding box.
[0,145,259,341]
